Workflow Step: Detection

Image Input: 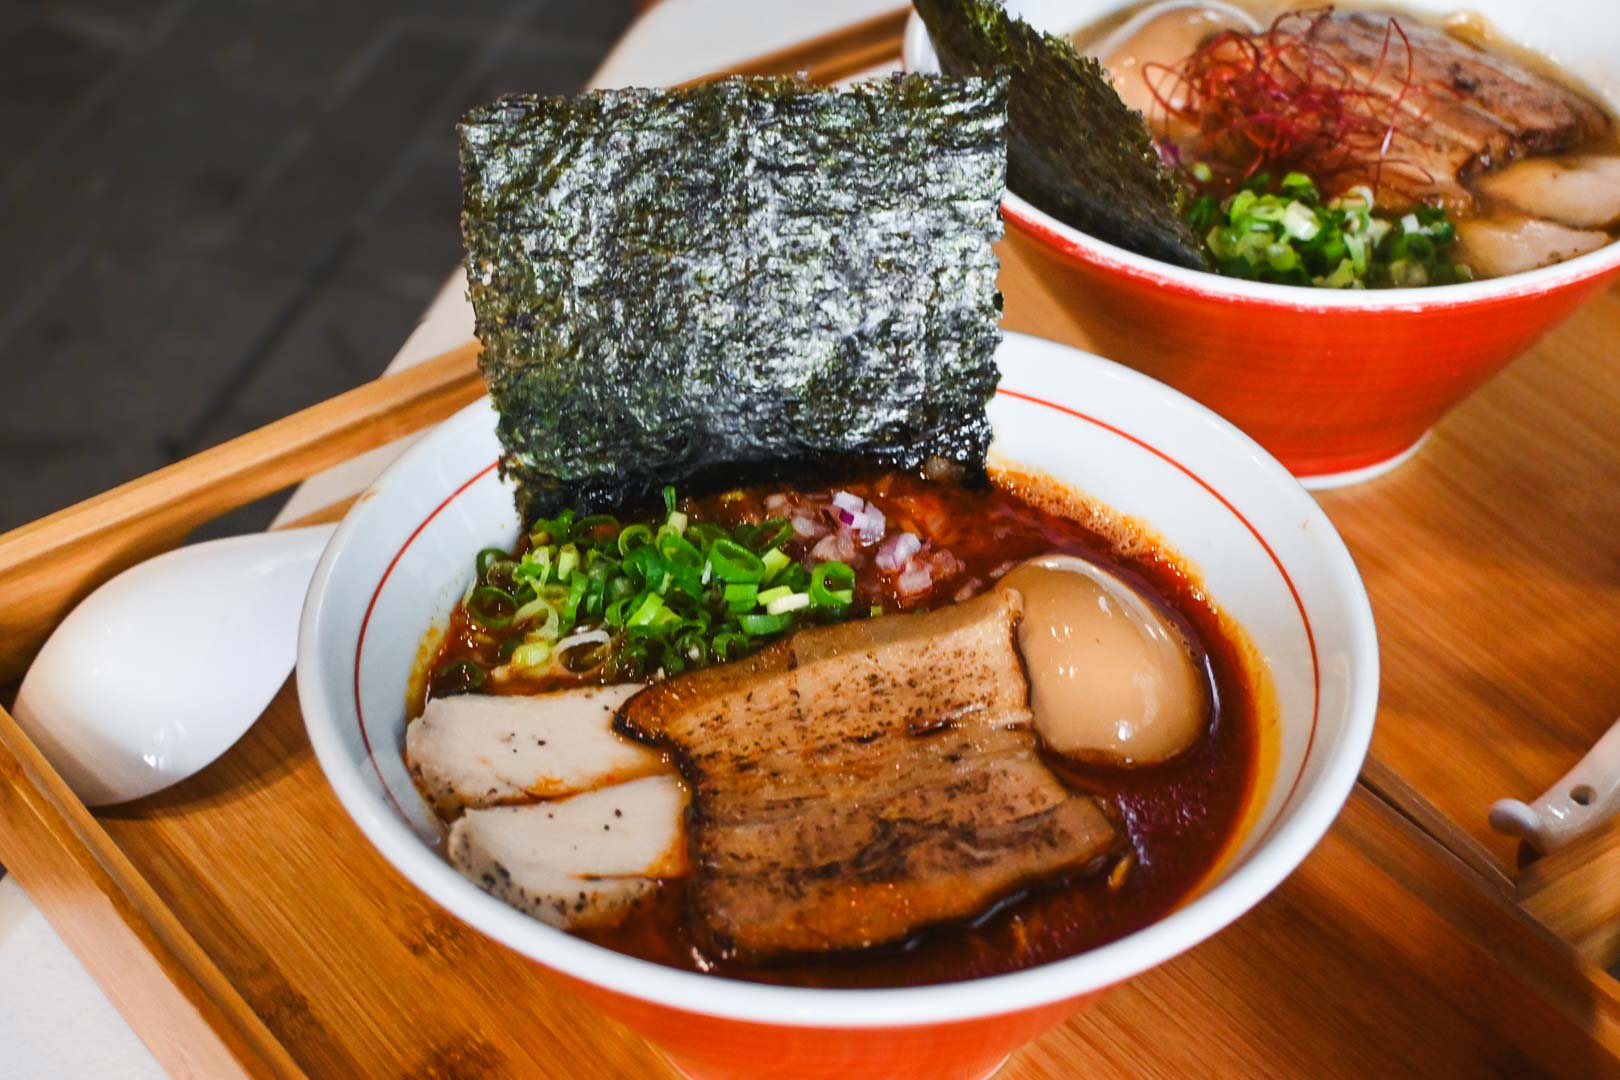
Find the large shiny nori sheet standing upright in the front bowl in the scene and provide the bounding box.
[460,74,1006,521]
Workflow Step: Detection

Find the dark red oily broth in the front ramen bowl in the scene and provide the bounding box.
[413,473,1262,988]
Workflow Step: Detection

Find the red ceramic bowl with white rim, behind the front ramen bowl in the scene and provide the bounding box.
[904,0,1620,487]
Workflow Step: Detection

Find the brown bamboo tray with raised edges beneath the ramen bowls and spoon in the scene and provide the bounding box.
[0,16,1620,1077]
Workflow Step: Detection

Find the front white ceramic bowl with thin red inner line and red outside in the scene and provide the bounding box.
[298,335,1379,1080]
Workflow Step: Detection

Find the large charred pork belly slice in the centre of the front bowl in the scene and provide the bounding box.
[619,589,1119,960]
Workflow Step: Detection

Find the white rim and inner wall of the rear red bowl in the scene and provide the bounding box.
[901,0,1620,313]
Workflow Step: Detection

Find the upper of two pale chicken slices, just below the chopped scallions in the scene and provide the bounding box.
[405,683,666,816]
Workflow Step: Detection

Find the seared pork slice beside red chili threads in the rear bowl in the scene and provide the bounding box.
[1312,13,1609,206]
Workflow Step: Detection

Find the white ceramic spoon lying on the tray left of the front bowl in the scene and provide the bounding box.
[13,525,335,806]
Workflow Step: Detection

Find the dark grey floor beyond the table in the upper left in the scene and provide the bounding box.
[0,0,633,533]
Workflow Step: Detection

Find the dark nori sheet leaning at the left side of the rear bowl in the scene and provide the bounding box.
[915,0,1210,270]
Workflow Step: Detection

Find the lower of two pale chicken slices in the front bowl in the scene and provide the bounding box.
[449,772,687,929]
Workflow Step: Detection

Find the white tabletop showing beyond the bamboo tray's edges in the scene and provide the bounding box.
[0,0,899,1080]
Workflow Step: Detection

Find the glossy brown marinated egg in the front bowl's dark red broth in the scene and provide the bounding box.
[1001,555,1210,764]
